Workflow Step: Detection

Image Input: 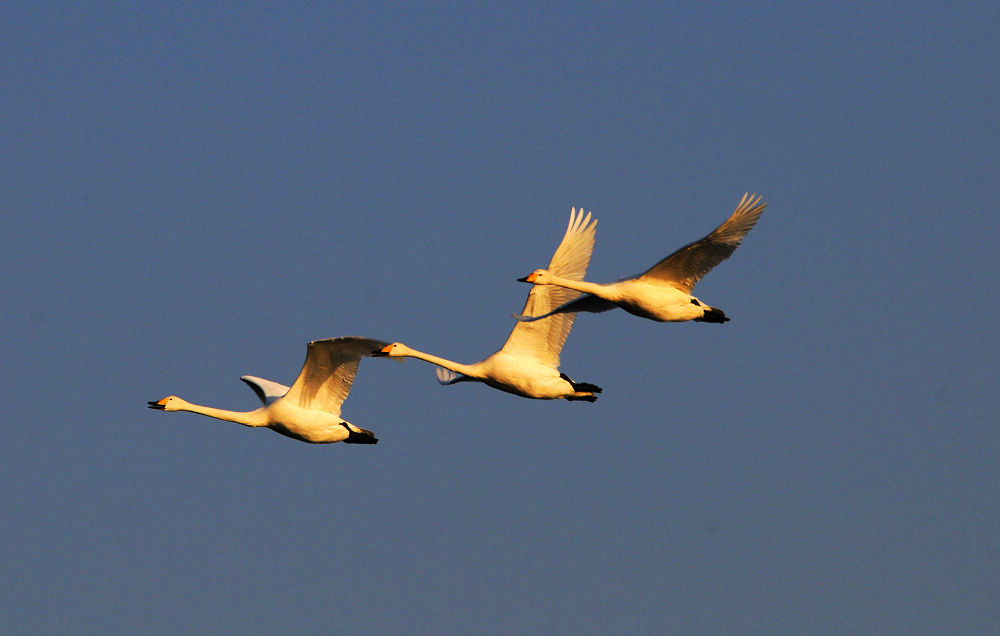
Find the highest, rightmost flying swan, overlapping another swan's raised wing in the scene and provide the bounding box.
[517,194,767,323]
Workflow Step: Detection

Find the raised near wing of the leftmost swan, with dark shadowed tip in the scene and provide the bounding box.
[285,336,388,416]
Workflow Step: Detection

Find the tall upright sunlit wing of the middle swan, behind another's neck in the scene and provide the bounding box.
[502,208,597,368]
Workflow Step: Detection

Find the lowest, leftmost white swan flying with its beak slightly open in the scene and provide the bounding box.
[148,337,386,444]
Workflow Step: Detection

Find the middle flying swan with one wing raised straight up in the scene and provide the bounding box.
[372,208,601,402]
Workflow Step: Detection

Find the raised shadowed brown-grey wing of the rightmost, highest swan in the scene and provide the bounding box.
[637,194,767,294]
